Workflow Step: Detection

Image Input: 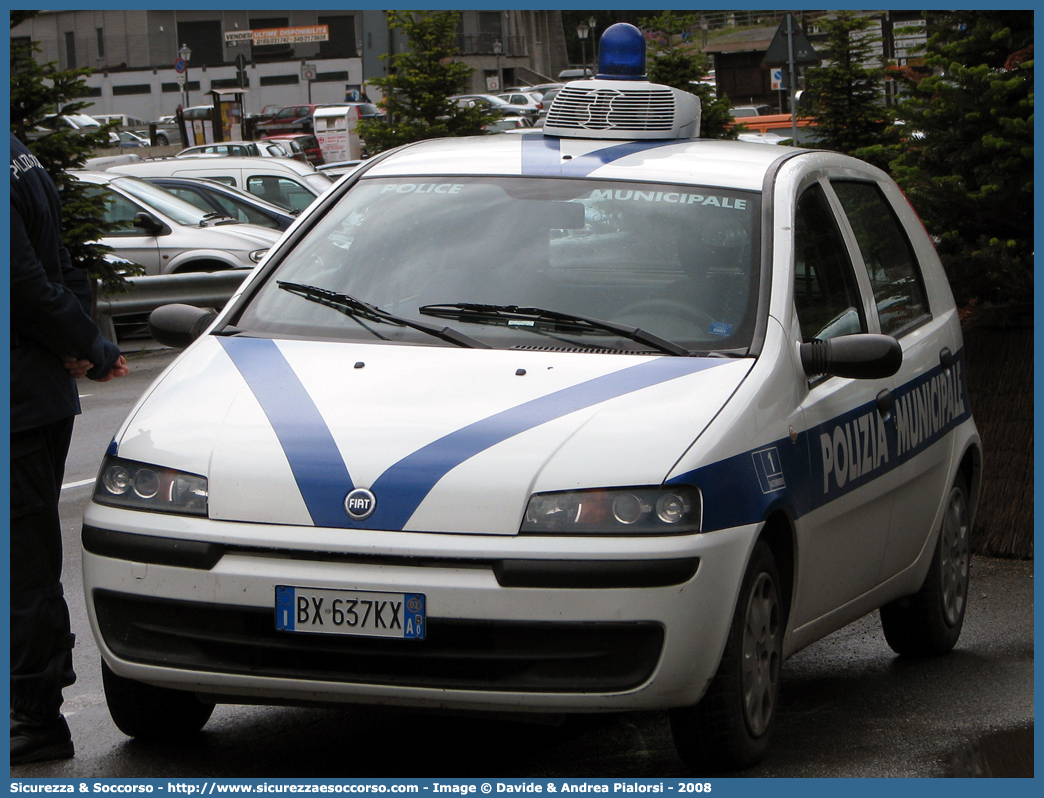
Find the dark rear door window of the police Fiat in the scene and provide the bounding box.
[831,181,929,335]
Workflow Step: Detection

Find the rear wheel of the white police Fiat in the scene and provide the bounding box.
[881,478,971,657]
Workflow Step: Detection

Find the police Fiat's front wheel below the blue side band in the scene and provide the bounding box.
[670,540,785,772]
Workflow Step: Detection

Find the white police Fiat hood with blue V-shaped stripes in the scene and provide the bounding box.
[117,336,753,534]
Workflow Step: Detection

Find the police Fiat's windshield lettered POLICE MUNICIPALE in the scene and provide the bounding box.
[233,177,761,354]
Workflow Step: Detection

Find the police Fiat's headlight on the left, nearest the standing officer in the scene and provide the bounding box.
[94,456,207,516]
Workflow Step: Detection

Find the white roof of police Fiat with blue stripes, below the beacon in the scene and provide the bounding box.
[362,133,789,190]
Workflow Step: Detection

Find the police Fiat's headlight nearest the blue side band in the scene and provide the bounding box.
[519,485,703,535]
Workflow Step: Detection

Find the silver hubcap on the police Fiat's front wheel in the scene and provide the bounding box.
[742,573,781,736]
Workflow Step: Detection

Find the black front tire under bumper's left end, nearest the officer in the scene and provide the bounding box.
[101,661,214,741]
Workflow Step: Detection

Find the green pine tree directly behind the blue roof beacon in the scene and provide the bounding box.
[641,11,737,139]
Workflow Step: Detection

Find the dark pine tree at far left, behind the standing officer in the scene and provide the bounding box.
[10,10,126,292]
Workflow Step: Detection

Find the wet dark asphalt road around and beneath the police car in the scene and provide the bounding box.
[10,352,1034,779]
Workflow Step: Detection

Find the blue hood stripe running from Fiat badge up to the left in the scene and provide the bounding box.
[218,338,354,526]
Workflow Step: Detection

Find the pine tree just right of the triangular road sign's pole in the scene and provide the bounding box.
[802,11,891,160]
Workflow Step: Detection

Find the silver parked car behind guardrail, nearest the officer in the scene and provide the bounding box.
[73,170,281,275]
